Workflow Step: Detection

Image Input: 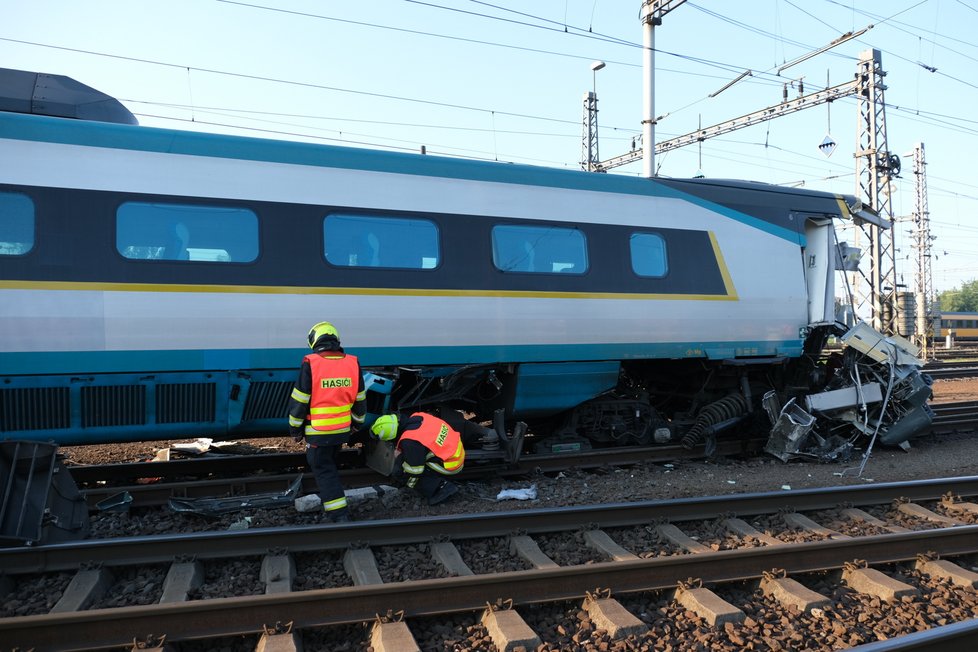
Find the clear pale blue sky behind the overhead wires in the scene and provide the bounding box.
[0,0,978,292]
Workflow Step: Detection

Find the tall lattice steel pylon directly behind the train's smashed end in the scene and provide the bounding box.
[853,49,900,335]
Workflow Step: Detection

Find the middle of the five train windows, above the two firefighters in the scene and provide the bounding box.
[323,213,441,269]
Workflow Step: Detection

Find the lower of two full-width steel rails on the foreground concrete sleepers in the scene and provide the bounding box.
[0,526,978,651]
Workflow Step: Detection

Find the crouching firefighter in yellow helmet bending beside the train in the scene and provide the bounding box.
[370,410,498,505]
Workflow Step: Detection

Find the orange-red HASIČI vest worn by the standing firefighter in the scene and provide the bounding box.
[306,351,360,437]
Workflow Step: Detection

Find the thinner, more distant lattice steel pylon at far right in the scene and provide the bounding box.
[911,143,934,359]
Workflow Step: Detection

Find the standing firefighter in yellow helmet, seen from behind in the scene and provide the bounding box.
[289,321,367,523]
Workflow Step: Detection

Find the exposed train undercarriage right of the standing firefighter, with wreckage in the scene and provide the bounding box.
[368,324,933,462]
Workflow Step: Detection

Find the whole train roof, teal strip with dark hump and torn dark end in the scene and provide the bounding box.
[0,69,868,242]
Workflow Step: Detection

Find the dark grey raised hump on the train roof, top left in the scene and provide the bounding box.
[0,68,139,125]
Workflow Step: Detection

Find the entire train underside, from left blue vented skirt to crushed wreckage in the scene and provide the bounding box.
[0,324,933,461]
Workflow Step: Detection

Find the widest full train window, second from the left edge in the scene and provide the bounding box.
[116,202,258,263]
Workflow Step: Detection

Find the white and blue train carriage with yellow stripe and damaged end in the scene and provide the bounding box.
[0,70,932,449]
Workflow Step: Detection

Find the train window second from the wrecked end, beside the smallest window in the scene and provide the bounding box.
[492,224,588,274]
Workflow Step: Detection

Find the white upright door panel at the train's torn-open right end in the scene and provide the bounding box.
[795,214,835,326]
